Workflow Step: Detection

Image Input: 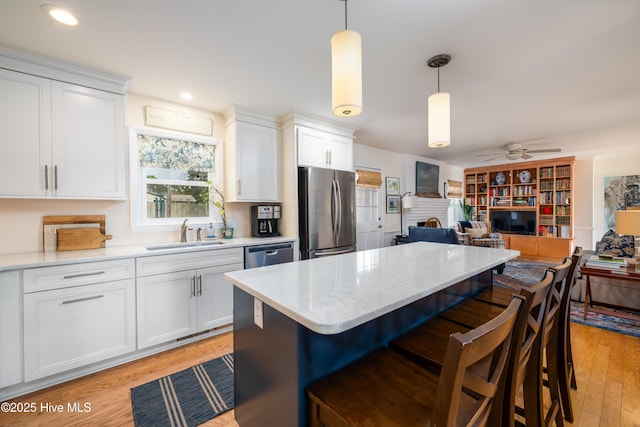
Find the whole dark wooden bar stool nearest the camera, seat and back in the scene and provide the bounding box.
[307,298,522,427]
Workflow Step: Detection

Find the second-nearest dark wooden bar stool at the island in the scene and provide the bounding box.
[390,271,555,426]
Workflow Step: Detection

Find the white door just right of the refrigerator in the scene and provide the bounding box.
[356,187,383,251]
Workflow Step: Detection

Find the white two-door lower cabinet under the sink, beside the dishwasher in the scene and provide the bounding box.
[137,248,244,349]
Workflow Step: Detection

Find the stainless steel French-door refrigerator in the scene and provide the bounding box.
[298,167,356,259]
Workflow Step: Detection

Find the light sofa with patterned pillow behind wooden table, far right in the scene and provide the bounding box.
[571,230,640,310]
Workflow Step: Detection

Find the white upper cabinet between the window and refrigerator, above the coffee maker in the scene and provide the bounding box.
[224,109,280,202]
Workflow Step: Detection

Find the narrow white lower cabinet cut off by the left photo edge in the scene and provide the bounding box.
[0,270,23,390]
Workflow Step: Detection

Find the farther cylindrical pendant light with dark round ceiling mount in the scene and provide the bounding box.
[427,54,451,148]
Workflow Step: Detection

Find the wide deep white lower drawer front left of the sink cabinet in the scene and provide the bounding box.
[24,279,135,381]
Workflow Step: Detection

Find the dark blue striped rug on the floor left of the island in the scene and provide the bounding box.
[131,353,234,427]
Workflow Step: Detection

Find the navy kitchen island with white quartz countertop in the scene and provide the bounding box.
[225,242,519,427]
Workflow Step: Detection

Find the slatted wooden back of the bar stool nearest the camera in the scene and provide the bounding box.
[431,296,523,426]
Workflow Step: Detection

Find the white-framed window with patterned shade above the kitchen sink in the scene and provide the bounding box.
[129,128,218,229]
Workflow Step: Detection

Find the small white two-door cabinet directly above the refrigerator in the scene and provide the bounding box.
[297,127,353,171]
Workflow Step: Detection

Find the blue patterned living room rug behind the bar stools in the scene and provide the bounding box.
[493,260,640,337]
